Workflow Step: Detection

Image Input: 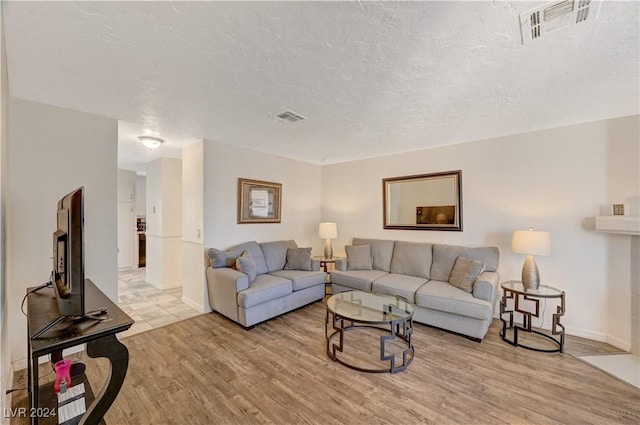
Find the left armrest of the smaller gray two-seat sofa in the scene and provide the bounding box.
[207,267,249,322]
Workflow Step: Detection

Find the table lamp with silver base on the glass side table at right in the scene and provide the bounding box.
[511,228,551,290]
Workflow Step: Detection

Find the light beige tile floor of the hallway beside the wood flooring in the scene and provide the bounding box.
[118,268,202,337]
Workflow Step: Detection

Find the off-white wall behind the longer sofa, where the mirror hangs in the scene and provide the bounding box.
[322,116,640,346]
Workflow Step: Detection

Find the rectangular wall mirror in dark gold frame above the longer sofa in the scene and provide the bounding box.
[382,170,462,231]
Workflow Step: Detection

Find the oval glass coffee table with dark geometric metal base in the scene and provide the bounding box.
[324,291,414,373]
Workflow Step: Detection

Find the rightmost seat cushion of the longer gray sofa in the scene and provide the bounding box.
[416,280,493,320]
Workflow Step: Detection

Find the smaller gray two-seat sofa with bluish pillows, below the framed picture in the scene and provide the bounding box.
[207,240,326,327]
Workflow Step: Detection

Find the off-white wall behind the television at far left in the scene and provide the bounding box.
[7,98,118,361]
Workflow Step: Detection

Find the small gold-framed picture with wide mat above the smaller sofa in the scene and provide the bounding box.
[238,178,282,224]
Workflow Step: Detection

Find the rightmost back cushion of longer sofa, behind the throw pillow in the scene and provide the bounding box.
[431,244,500,282]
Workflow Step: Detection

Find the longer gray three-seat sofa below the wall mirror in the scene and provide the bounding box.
[331,238,499,341]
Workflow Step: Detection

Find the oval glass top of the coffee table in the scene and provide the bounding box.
[327,291,413,323]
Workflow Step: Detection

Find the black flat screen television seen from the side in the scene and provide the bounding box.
[52,187,85,316]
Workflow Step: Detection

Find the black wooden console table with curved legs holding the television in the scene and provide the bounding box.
[27,279,134,425]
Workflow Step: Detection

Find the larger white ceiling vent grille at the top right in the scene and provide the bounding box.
[520,0,601,44]
